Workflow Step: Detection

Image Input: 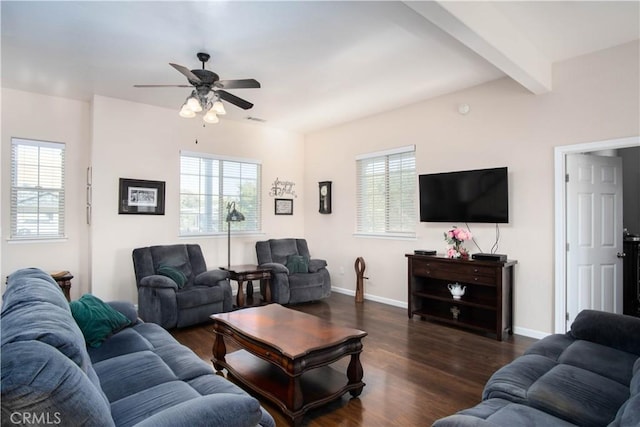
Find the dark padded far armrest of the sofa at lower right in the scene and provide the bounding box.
[571,310,640,356]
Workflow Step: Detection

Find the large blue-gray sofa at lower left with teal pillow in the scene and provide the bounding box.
[0,269,275,427]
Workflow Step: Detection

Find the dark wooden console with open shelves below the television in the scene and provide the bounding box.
[406,254,517,340]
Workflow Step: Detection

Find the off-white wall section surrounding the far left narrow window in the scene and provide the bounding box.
[0,89,91,298]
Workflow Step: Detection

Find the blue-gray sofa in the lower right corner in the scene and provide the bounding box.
[433,310,640,427]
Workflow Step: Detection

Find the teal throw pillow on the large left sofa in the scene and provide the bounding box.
[69,294,131,347]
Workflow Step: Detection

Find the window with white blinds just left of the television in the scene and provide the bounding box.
[356,145,416,237]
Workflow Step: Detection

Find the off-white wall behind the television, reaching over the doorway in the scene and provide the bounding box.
[305,42,640,335]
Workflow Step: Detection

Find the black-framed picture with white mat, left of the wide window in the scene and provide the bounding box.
[118,178,164,215]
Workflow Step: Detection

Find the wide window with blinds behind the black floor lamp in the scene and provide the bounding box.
[180,152,261,236]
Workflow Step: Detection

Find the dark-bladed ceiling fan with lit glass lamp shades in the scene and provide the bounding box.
[133,52,260,123]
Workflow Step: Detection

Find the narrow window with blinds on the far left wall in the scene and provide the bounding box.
[11,138,65,240]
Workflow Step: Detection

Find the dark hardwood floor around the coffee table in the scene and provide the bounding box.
[172,293,536,427]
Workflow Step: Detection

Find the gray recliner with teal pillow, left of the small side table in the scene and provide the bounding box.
[133,244,233,329]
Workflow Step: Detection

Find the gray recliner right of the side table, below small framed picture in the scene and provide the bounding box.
[256,239,331,304]
